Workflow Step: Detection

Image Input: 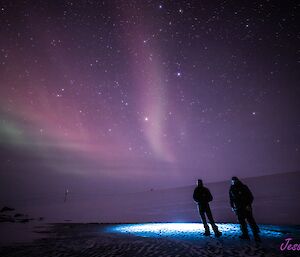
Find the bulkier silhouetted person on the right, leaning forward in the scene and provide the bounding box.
[229,177,260,242]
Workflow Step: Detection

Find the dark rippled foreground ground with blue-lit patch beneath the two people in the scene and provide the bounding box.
[0,223,300,257]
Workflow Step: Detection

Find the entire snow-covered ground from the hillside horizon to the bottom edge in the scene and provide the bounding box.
[0,172,300,257]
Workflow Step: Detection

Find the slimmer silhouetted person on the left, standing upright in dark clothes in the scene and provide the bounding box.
[193,179,222,237]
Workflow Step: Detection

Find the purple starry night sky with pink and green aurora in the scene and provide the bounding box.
[0,0,300,198]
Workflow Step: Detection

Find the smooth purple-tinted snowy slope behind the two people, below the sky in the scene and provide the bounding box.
[0,172,300,225]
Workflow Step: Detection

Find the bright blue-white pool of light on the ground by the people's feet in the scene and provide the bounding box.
[108,223,282,238]
